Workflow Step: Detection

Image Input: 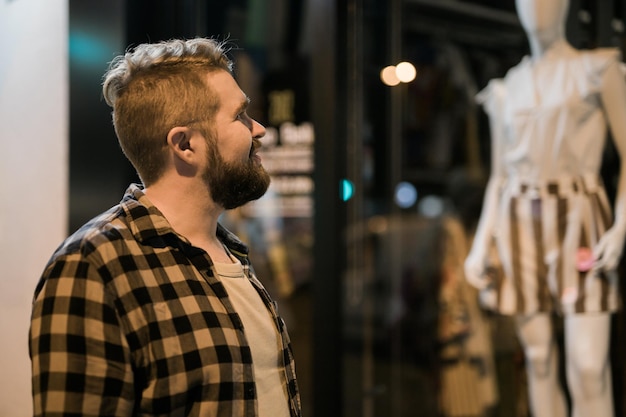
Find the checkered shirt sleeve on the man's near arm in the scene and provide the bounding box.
[29,249,134,417]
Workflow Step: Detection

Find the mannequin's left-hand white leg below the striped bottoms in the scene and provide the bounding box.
[515,313,564,417]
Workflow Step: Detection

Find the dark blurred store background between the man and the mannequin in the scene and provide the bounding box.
[68,0,626,417]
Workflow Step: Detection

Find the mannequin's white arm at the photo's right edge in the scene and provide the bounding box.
[594,62,626,270]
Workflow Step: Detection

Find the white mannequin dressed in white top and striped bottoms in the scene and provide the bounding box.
[465,0,626,417]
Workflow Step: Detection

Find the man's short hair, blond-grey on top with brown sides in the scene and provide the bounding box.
[102,38,233,186]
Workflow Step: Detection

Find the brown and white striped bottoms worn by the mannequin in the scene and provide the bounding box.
[490,176,620,314]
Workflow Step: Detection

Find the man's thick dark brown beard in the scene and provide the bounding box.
[203,148,270,210]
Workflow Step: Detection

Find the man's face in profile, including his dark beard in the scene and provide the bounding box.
[202,71,270,210]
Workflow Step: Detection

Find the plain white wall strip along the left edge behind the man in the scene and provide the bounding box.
[0,0,68,417]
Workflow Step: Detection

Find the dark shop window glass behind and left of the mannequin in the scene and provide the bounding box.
[342,0,624,417]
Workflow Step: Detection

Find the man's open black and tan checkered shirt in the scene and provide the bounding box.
[29,185,301,417]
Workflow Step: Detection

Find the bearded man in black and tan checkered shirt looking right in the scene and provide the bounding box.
[30,39,300,417]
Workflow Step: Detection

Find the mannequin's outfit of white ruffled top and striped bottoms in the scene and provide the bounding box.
[477,45,621,314]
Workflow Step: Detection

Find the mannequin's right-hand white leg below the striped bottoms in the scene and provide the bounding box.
[565,313,614,417]
